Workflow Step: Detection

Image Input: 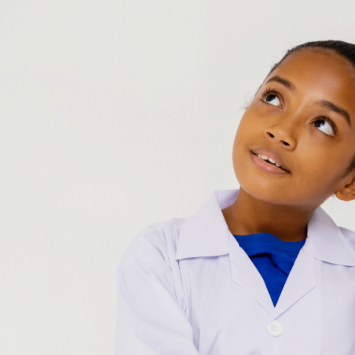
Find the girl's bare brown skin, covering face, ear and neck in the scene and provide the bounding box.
[222,48,355,242]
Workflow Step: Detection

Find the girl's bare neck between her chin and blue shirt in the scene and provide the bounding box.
[222,188,314,242]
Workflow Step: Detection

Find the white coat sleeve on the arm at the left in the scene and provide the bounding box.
[115,229,198,355]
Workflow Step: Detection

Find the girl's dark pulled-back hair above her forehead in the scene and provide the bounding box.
[268,40,355,177]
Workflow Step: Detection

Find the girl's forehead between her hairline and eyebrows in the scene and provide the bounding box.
[268,48,355,103]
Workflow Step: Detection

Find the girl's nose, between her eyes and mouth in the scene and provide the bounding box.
[264,121,296,150]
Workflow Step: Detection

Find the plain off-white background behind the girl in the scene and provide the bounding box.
[0,0,355,355]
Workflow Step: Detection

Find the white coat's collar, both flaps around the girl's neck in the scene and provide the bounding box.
[176,190,355,266]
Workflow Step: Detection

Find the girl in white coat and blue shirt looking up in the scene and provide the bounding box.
[115,41,355,355]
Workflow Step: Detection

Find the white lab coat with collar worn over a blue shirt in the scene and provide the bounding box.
[115,190,355,355]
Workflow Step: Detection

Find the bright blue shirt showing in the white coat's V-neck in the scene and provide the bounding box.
[234,233,306,306]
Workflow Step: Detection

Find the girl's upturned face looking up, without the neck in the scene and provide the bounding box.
[233,49,355,208]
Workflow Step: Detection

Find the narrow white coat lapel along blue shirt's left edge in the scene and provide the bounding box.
[229,234,274,314]
